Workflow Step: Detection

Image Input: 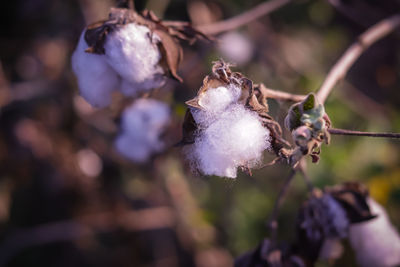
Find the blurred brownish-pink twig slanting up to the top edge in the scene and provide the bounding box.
[196,0,291,34]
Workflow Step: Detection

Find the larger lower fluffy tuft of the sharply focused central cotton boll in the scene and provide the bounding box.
[191,104,270,178]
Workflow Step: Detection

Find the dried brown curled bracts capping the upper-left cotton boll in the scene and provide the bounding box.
[85,8,210,82]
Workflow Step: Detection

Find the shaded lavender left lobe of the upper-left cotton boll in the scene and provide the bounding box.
[72,32,119,108]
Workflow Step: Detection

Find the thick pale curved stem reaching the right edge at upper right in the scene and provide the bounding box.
[317,14,400,103]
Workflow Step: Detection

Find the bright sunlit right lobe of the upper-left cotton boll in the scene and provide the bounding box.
[104,23,165,95]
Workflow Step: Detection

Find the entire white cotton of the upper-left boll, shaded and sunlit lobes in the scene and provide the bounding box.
[72,23,165,108]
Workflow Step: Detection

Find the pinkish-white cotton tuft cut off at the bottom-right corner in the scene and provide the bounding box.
[349,198,400,267]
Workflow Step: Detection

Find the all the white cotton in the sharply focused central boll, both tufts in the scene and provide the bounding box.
[189,86,270,178]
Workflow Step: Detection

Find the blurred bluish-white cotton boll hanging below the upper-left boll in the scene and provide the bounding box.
[115,99,170,163]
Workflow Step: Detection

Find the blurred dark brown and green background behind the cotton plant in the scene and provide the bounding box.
[0,0,400,266]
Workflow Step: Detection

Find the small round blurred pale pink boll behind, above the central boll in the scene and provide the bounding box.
[218,32,254,65]
